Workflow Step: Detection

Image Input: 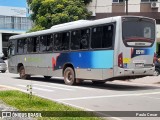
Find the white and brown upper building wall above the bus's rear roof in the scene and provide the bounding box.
[88,0,160,19]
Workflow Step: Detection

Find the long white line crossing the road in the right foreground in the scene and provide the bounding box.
[57,92,160,101]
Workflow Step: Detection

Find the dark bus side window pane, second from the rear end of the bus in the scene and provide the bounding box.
[91,27,102,48]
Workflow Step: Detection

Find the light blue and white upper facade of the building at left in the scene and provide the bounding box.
[0,0,32,33]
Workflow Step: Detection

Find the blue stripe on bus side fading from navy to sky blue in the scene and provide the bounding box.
[56,50,114,69]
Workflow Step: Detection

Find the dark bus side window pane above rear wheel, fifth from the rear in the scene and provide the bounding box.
[61,32,70,50]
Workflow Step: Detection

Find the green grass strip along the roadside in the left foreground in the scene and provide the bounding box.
[0,90,102,120]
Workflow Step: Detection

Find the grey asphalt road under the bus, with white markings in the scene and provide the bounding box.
[0,73,160,120]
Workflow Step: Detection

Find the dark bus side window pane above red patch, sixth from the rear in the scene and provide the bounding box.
[54,33,62,51]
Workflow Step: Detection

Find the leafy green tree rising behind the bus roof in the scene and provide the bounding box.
[28,0,91,31]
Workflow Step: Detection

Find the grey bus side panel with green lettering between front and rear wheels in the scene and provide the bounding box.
[25,53,62,77]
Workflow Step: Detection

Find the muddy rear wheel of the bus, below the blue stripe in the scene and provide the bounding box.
[64,67,76,85]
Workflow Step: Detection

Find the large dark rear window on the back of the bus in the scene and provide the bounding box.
[122,17,155,47]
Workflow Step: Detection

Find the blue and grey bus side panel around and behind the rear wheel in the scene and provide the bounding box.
[55,50,114,80]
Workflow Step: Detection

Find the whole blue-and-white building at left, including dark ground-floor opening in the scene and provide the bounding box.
[0,0,32,57]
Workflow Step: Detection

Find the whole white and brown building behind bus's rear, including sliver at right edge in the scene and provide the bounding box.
[87,0,160,55]
